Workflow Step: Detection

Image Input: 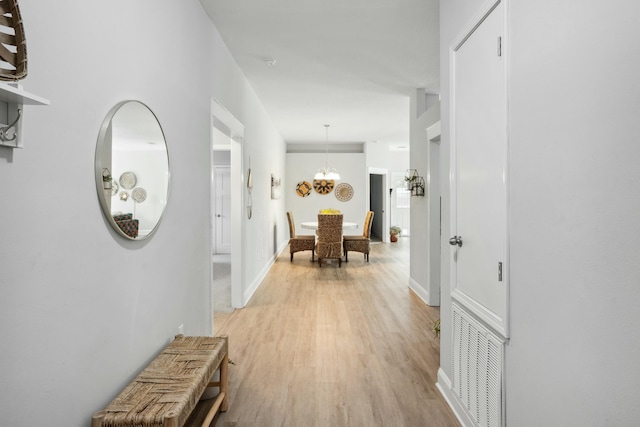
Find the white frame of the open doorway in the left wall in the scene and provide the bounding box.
[209,98,244,310]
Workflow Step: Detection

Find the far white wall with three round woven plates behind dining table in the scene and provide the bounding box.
[284,153,369,235]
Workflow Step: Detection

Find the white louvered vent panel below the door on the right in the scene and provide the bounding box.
[452,304,504,427]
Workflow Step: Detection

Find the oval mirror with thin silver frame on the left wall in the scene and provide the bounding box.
[95,101,169,240]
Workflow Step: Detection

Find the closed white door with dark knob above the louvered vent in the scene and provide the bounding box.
[450,3,508,337]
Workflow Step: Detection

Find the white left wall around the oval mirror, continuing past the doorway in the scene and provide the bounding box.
[0,0,286,427]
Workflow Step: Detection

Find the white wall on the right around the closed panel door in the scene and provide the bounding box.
[441,0,640,426]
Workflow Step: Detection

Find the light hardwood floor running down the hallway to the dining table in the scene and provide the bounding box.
[192,238,459,427]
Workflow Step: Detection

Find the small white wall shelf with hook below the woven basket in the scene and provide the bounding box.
[0,83,50,148]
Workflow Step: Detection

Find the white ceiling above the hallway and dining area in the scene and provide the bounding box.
[200,0,440,146]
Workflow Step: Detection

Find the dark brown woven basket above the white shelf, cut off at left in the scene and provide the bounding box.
[0,0,27,81]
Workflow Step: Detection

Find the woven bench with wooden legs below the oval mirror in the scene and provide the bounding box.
[91,335,229,427]
